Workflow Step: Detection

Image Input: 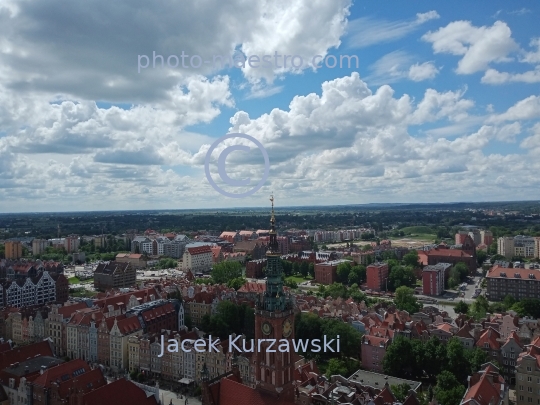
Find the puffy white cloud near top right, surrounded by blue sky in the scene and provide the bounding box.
[422,21,518,74]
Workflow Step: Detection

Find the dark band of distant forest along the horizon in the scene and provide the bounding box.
[0,201,540,239]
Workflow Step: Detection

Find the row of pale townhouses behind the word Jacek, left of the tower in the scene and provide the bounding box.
[128,327,256,387]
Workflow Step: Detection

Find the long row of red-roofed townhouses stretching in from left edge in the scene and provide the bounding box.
[0,288,184,370]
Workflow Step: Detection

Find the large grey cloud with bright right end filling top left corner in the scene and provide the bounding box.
[0,0,351,99]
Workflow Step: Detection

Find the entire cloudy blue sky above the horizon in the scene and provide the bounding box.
[0,0,540,213]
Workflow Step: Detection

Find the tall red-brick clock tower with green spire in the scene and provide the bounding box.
[255,196,294,398]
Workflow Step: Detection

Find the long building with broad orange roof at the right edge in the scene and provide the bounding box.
[486,266,540,301]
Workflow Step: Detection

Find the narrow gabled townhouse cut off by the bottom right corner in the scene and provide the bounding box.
[516,336,540,405]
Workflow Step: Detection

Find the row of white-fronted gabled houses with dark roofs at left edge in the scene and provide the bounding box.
[0,271,69,308]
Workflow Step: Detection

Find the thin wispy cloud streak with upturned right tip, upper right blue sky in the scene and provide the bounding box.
[348,10,440,48]
